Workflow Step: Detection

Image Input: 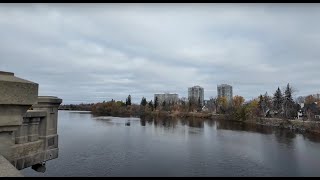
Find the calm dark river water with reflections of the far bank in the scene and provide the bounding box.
[22,111,320,176]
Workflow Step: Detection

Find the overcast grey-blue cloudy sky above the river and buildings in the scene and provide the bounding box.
[0,4,320,104]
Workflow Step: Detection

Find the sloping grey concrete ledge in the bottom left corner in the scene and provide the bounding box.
[0,155,23,177]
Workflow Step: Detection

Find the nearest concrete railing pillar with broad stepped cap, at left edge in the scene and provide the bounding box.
[0,71,38,159]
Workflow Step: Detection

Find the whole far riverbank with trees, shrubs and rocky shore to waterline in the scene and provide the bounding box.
[59,84,320,135]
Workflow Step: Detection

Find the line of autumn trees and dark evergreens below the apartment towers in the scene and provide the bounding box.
[58,83,317,120]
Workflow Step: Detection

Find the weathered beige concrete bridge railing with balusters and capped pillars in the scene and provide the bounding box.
[0,71,62,175]
